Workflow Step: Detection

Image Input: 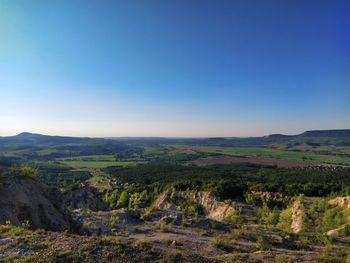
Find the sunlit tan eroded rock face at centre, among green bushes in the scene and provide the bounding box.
[156,191,235,221]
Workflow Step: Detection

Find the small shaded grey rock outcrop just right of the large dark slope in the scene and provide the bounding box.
[64,186,108,211]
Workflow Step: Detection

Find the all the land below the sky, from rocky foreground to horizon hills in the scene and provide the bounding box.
[0,130,350,263]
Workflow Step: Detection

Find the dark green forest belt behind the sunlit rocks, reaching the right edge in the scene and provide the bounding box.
[105,162,350,198]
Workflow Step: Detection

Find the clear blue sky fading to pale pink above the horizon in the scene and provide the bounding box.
[0,0,350,136]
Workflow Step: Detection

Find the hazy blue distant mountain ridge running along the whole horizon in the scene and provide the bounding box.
[0,129,350,147]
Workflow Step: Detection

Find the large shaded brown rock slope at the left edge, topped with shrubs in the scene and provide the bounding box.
[0,177,69,231]
